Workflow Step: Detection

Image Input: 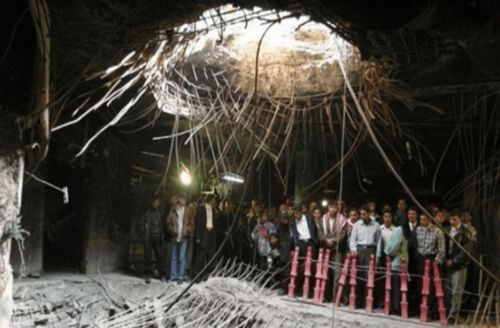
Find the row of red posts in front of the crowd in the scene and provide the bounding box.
[288,247,447,325]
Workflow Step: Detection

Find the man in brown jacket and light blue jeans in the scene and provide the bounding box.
[167,193,194,283]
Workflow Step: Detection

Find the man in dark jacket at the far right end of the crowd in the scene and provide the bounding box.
[446,211,471,322]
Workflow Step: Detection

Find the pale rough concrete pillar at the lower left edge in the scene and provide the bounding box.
[0,153,23,328]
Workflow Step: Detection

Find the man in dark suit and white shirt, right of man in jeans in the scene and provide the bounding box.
[194,195,217,274]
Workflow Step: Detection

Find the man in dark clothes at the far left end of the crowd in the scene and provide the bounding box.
[142,197,165,283]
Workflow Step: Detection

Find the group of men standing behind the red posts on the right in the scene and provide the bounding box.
[280,200,476,320]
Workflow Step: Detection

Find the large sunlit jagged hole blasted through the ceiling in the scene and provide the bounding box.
[146,6,361,116]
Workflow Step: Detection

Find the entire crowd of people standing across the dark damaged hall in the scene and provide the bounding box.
[136,193,477,320]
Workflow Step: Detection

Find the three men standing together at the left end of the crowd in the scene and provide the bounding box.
[140,193,216,283]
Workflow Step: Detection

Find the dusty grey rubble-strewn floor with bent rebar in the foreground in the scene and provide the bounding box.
[13,274,437,328]
